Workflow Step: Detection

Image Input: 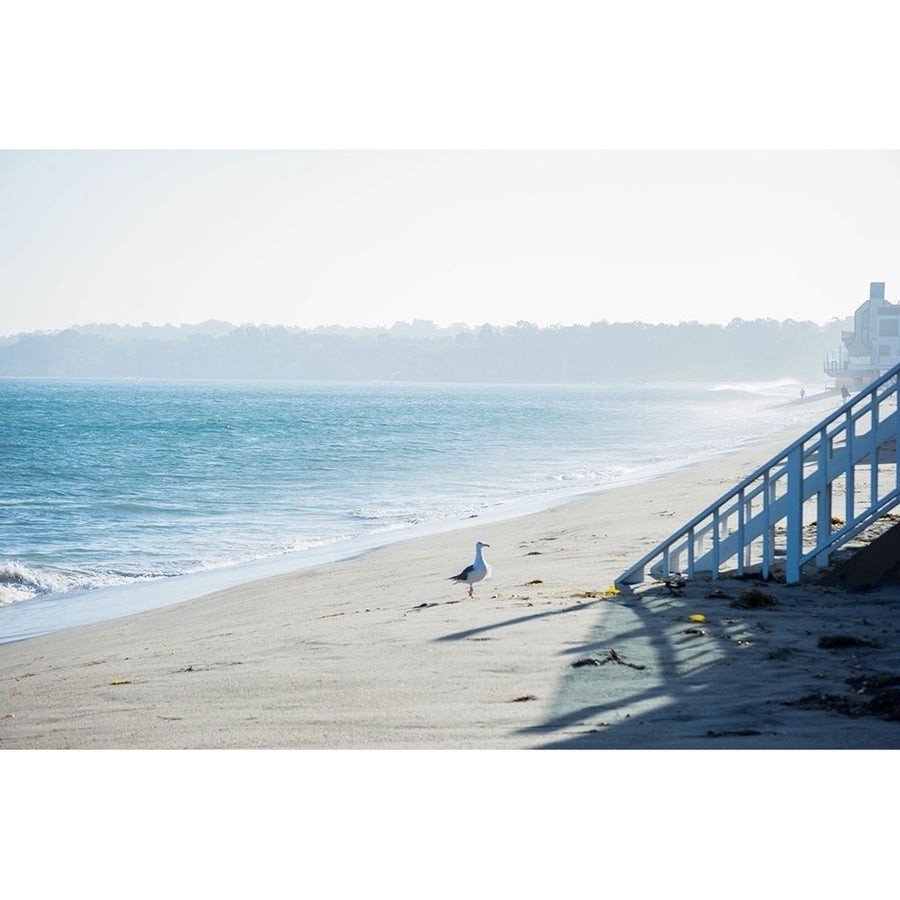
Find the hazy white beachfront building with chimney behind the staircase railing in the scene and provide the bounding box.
[825,281,900,391]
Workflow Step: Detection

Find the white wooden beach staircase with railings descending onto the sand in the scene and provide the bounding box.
[616,365,900,586]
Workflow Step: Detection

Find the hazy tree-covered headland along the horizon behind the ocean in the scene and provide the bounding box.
[0,319,850,384]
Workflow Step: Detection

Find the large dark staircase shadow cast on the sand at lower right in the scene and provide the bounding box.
[437,571,900,750]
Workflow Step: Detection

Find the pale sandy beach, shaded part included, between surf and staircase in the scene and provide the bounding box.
[0,390,900,750]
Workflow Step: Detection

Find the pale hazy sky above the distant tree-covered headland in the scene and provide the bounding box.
[0,151,900,334]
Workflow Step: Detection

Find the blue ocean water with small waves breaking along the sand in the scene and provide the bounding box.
[0,379,802,642]
